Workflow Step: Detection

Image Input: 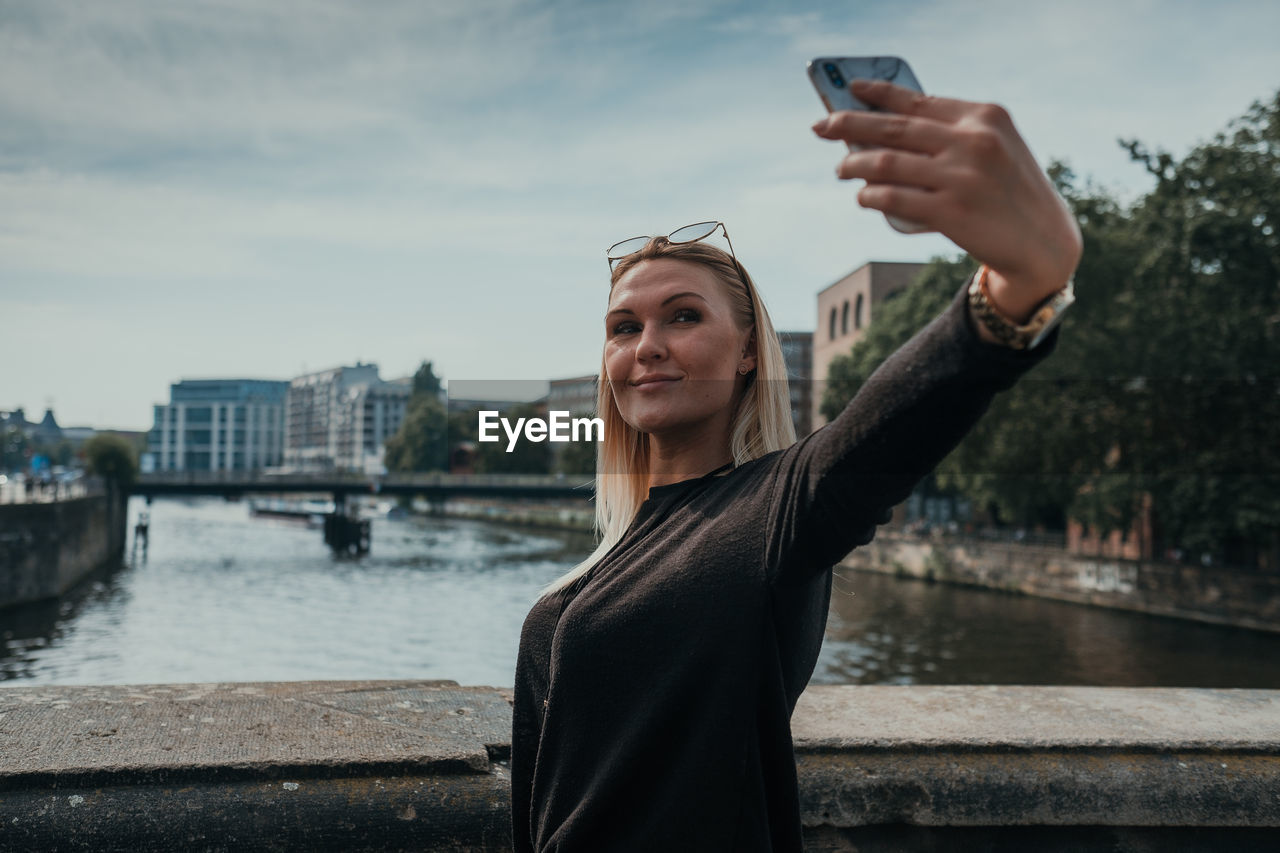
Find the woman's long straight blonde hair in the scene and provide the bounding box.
[541,237,796,596]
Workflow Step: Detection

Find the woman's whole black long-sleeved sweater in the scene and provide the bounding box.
[511,281,1057,853]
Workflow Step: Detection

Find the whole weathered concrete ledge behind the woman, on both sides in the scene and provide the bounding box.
[0,681,1280,852]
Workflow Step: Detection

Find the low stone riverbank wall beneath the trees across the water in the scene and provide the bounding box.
[841,530,1280,631]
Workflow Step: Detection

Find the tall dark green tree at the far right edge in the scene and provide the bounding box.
[1119,92,1280,562]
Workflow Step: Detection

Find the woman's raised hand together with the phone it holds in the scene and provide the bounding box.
[809,58,1082,312]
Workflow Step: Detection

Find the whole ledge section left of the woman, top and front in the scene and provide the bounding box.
[0,681,511,852]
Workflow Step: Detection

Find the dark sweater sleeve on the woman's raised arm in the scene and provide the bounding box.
[767,279,1057,583]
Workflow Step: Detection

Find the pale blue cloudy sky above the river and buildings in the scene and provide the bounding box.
[0,0,1280,429]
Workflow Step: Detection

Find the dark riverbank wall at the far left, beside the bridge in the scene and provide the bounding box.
[0,491,127,608]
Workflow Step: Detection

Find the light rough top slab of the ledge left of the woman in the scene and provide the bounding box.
[0,681,511,790]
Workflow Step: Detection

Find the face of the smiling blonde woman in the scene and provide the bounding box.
[604,257,755,437]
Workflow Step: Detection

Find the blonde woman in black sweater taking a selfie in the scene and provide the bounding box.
[512,76,1080,852]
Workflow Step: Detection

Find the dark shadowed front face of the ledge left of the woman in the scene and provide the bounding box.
[0,771,511,853]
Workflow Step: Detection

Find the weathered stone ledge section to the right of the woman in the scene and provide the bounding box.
[792,686,1280,827]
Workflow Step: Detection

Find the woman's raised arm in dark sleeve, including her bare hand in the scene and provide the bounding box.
[769,81,1082,579]
